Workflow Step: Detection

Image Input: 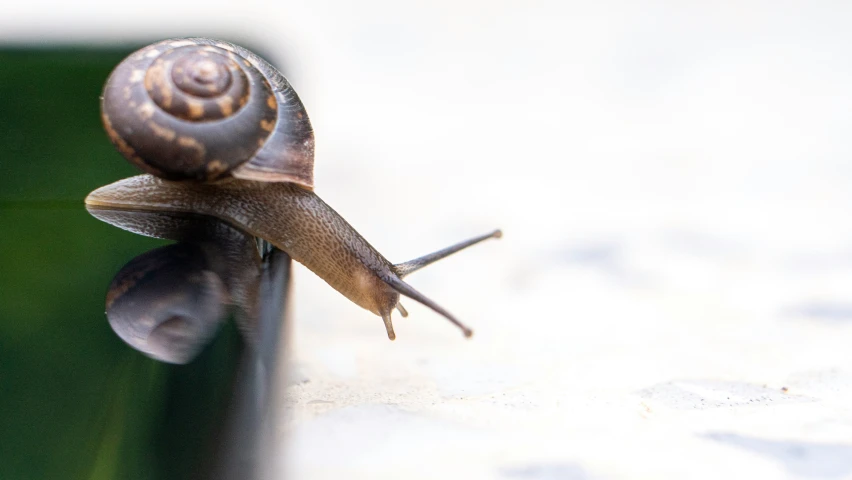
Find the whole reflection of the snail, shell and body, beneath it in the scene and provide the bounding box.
[89,208,261,363]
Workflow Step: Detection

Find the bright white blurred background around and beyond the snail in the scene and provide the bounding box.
[6,0,852,479]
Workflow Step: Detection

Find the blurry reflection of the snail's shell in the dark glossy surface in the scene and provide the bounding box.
[106,243,228,363]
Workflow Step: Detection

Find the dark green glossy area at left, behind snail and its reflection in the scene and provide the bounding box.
[0,48,241,480]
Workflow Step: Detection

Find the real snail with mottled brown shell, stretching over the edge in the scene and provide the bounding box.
[85,38,502,340]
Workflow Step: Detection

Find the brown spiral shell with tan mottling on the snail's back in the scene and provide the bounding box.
[101,38,314,188]
